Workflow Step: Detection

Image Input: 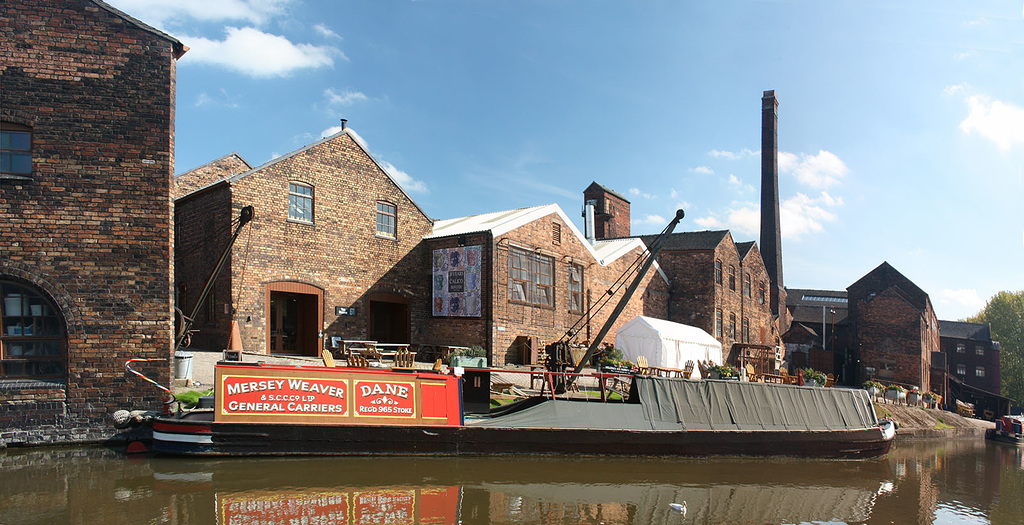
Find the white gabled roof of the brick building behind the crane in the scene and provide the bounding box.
[423,204,668,274]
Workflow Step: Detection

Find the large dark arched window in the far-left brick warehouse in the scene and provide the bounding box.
[0,280,68,379]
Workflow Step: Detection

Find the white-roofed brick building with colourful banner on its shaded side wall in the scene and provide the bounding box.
[427,205,668,364]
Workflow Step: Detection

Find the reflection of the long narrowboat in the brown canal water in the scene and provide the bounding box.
[153,457,892,525]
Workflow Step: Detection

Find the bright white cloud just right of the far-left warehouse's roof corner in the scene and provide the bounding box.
[181,28,344,77]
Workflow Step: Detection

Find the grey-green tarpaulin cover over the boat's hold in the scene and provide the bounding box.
[466,377,878,431]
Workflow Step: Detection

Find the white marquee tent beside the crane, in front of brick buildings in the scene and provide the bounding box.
[615,315,723,378]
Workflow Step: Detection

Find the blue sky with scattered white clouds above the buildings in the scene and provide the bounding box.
[108,0,1024,319]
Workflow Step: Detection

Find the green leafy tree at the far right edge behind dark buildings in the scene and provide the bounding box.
[967,291,1024,402]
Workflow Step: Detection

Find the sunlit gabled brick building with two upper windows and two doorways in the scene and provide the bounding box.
[175,128,431,355]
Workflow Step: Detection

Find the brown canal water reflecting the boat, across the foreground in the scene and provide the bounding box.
[0,437,1024,525]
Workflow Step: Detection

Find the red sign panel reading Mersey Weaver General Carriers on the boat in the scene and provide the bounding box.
[221,376,348,415]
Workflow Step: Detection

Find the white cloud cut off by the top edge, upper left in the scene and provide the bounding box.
[108,0,291,27]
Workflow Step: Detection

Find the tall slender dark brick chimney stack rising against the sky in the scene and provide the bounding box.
[761,90,788,333]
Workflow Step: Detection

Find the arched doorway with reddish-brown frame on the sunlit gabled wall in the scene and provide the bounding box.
[265,282,324,355]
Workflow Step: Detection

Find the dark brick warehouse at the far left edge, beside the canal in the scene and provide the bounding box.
[0,0,185,445]
